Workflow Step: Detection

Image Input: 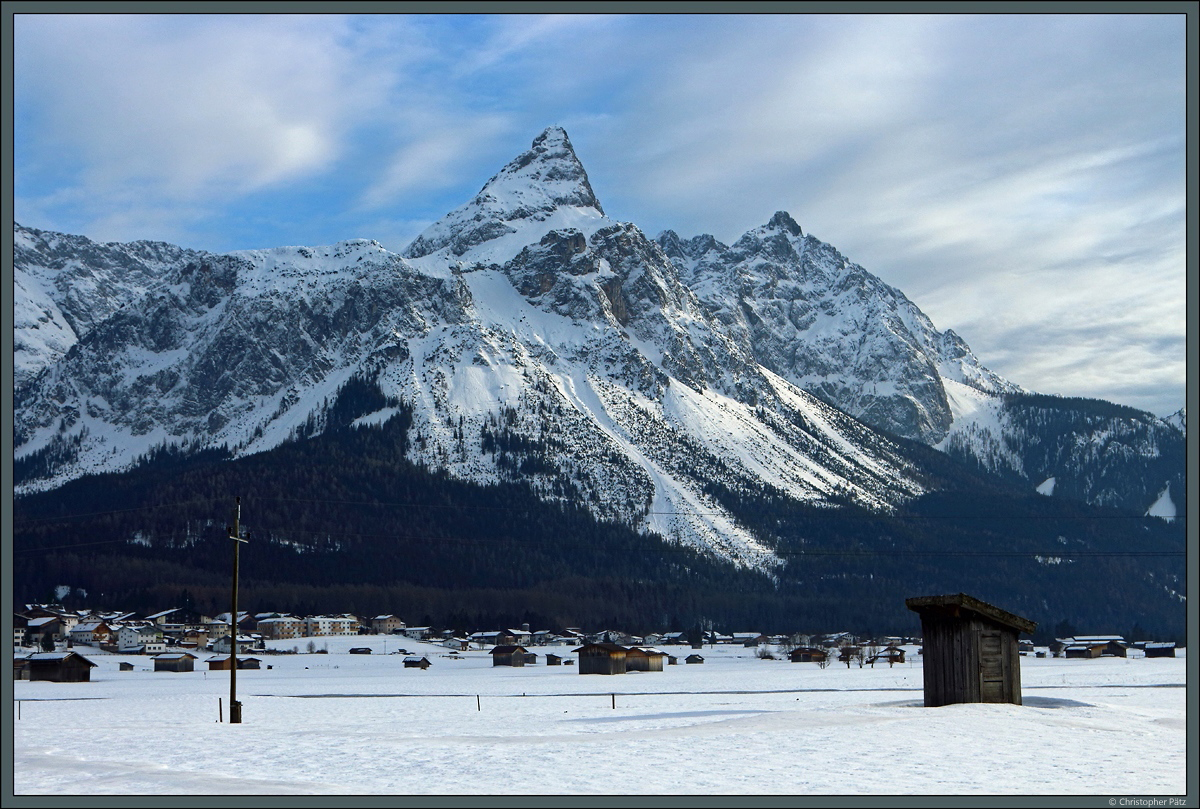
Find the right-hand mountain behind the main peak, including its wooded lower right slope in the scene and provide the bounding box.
[658,211,1184,513]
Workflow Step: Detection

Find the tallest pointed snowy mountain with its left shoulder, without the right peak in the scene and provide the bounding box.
[16,128,940,568]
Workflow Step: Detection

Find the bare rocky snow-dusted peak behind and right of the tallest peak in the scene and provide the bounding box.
[659,211,1020,444]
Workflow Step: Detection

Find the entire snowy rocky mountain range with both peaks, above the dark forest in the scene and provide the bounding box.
[14,127,1185,554]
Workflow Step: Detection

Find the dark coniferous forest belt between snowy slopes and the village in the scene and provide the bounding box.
[14,379,1184,639]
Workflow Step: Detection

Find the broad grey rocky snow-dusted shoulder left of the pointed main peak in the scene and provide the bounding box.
[14,241,461,487]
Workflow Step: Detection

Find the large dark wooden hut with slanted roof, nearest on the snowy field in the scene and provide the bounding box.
[905,593,1037,707]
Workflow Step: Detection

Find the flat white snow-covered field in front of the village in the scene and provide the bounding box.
[12,636,1187,796]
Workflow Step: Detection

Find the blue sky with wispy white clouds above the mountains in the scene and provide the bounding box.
[14,14,1186,414]
